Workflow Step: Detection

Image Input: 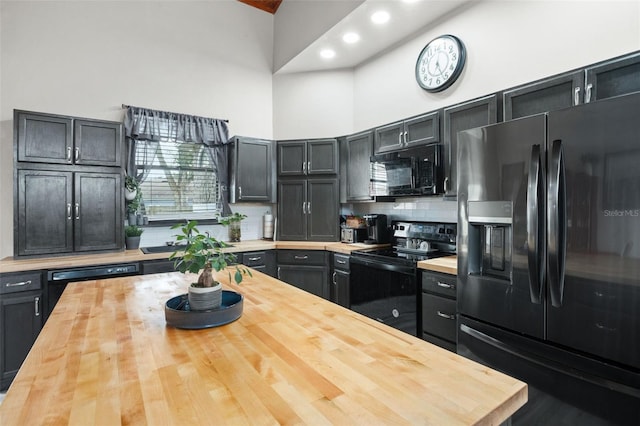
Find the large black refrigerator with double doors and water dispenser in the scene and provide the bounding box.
[457,93,640,425]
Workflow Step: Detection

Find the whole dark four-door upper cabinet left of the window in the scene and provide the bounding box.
[14,110,124,257]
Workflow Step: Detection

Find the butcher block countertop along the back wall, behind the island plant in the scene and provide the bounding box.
[0,240,388,272]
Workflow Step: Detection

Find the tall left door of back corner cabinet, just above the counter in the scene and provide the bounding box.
[277,180,308,241]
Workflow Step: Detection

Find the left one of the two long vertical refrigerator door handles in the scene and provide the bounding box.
[527,145,546,304]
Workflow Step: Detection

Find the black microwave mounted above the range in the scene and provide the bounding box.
[369,144,444,197]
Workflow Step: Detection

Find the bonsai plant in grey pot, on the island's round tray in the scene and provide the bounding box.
[169,221,251,310]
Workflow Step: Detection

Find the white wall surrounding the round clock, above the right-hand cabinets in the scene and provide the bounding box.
[274,0,640,138]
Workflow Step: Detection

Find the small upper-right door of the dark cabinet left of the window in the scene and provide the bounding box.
[73,119,122,167]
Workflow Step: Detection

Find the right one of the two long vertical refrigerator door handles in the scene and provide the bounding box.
[547,140,567,308]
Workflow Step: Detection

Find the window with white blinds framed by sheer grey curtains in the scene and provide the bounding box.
[135,138,220,221]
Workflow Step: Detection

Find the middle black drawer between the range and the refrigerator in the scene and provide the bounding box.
[422,293,456,342]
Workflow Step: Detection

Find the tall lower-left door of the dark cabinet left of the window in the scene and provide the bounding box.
[14,169,73,256]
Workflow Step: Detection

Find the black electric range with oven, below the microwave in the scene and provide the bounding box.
[349,222,456,336]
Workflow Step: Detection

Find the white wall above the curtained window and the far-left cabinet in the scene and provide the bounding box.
[0,0,273,258]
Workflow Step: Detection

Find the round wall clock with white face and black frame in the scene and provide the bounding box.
[416,35,466,92]
